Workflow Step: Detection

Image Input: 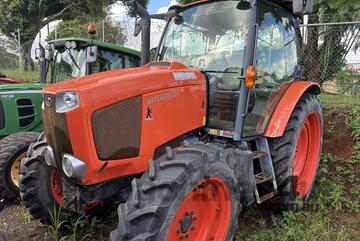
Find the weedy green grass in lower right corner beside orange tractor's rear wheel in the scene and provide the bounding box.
[236,105,360,241]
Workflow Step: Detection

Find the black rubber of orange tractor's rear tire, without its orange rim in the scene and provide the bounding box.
[268,93,323,211]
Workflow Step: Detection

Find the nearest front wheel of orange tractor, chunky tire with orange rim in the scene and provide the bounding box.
[110,143,245,241]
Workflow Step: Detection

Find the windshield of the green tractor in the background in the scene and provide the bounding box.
[54,48,86,82]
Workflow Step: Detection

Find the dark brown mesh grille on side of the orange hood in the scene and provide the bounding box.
[92,97,141,161]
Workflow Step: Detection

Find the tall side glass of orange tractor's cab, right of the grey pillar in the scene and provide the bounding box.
[242,1,298,137]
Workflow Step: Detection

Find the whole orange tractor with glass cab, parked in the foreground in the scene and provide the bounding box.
[20,0,323,241]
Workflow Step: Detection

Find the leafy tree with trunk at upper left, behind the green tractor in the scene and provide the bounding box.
[0,0,114,70]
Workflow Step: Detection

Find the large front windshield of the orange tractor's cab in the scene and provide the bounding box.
[160,1,248,72]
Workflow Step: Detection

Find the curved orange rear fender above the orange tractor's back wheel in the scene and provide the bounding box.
[264,81,320,138]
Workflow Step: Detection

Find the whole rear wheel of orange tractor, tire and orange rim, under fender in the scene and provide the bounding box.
[269,93,323,211]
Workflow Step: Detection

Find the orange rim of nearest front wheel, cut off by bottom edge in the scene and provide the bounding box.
[167,178,231,241]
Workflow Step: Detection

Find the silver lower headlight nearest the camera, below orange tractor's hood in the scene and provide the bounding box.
[62,154,86,181]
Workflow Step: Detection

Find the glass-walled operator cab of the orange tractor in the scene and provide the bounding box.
[158,0,312,140]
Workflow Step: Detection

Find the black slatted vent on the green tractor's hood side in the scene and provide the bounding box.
[16,99,35,128]
